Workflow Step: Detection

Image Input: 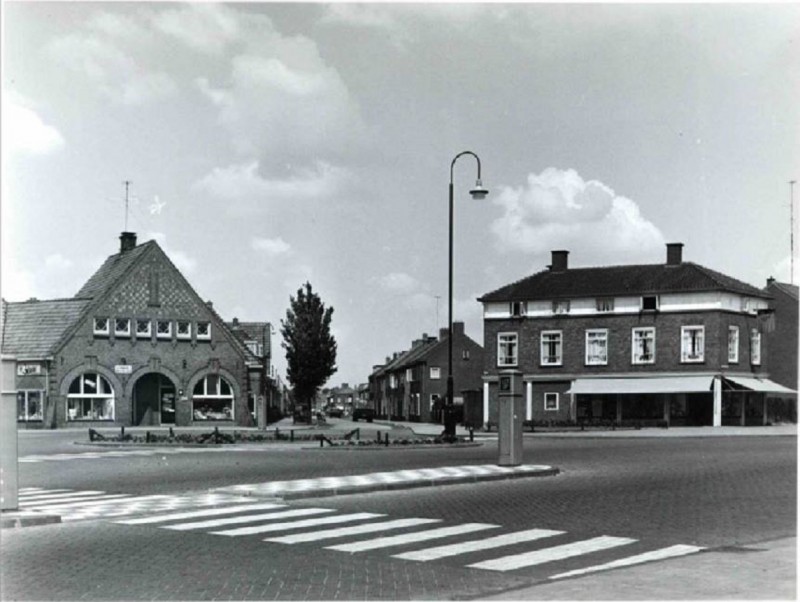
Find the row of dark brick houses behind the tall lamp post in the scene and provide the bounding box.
[369,322,483,423]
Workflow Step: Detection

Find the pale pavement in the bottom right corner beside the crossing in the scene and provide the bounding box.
[481,537,798,600]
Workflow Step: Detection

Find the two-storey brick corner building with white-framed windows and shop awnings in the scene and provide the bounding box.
[479,243,797,426]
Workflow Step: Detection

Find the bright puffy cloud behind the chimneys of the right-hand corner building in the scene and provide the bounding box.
[491,167,664,265]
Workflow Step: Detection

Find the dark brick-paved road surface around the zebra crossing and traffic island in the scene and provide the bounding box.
[2,434,797,600]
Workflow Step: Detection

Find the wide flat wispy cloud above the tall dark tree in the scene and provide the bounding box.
[194,161,350,206]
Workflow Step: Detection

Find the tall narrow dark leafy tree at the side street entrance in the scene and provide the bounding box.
[281,282,336,417]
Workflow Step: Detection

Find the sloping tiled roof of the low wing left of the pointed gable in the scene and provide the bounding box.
[2,298,91,359]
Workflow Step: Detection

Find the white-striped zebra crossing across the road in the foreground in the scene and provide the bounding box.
[104,490,704,580]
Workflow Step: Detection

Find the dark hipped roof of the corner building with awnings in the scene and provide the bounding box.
[478,262,769,303]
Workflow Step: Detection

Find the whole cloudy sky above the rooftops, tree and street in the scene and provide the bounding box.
[0,1,800,386]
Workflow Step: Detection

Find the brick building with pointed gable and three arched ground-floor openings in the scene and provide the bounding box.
[2,232,270,428]
